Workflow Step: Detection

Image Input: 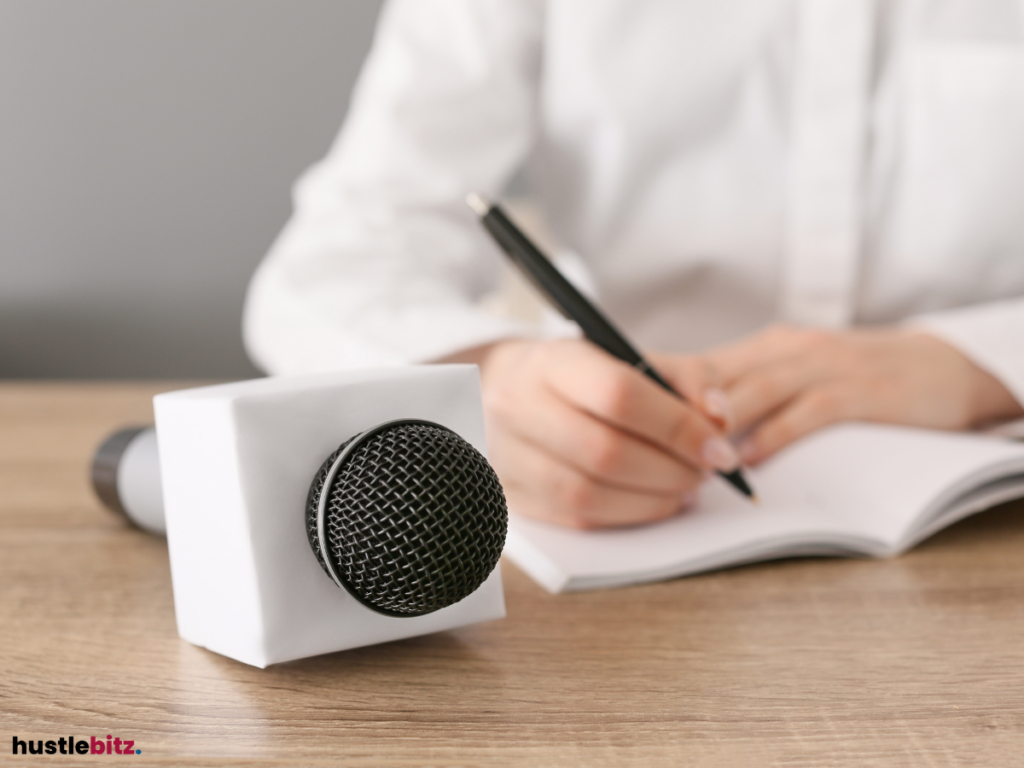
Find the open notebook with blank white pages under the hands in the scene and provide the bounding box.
[505,424,1024,592]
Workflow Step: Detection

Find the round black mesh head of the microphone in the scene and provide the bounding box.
[306,420,508,616]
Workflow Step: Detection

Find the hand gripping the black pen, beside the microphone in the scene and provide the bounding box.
[477,340,739,528]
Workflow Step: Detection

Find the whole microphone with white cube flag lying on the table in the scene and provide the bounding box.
[92,366,508,667]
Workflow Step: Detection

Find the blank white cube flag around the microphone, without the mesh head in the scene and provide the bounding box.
[154,366,505,667]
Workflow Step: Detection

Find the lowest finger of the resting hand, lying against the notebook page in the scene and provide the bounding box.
[739,384,859,464]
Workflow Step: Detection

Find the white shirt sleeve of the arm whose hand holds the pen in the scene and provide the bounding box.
[244,0,543,374]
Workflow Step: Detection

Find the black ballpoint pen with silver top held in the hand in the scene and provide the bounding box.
[466,194,757,501]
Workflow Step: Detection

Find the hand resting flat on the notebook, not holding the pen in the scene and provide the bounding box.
[705,326,1024,464]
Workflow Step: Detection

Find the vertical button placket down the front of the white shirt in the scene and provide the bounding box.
[780,0,876,328]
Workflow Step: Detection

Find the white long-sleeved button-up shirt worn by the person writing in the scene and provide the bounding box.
[245,0,1024,409]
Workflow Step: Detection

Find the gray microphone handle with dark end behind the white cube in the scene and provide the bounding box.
[91,427,167,535]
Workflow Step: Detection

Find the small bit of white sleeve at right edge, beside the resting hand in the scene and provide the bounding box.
[906,299,1024,404]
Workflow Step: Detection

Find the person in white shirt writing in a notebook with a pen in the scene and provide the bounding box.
[244,0,1024,527]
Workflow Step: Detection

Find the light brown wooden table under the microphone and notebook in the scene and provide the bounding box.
[0,384,1024,766]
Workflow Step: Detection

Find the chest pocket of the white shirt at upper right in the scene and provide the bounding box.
[886,42,1024,308]
